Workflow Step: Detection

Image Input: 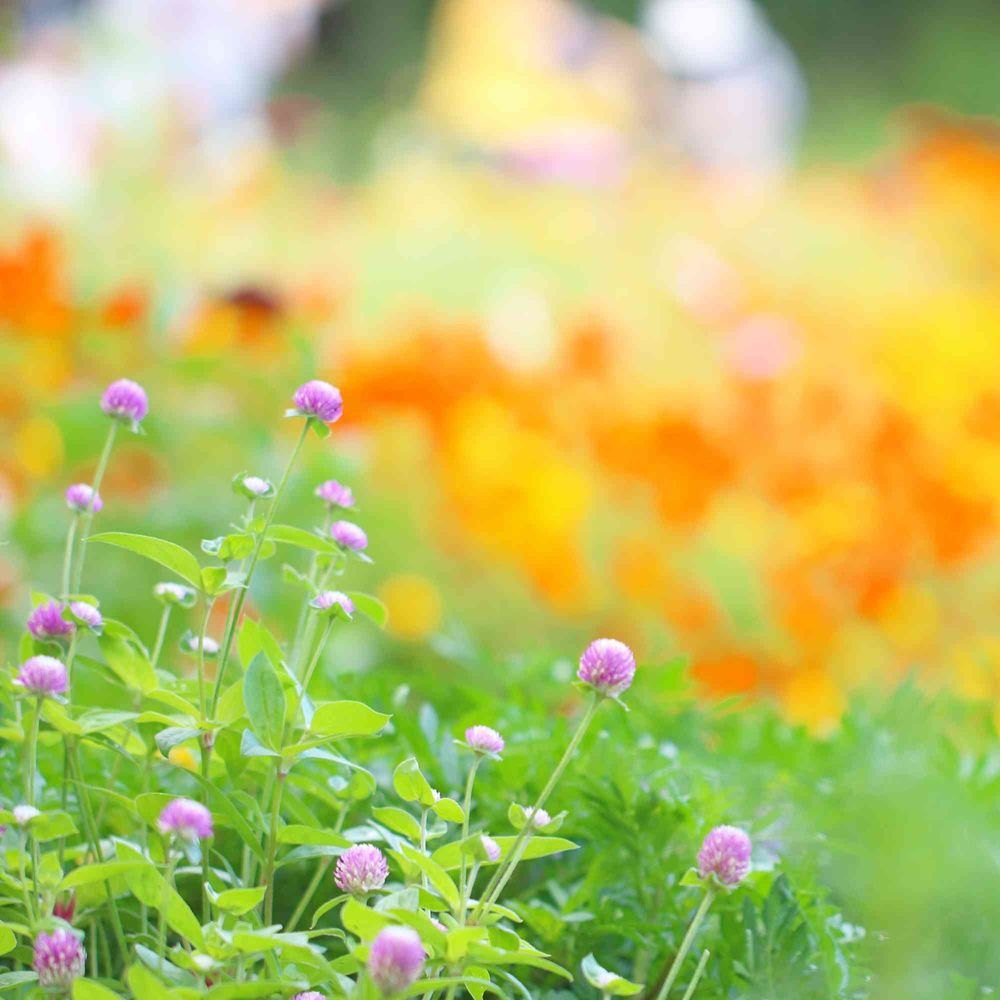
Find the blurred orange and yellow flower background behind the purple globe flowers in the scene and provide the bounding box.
[0,0,1000,730]
